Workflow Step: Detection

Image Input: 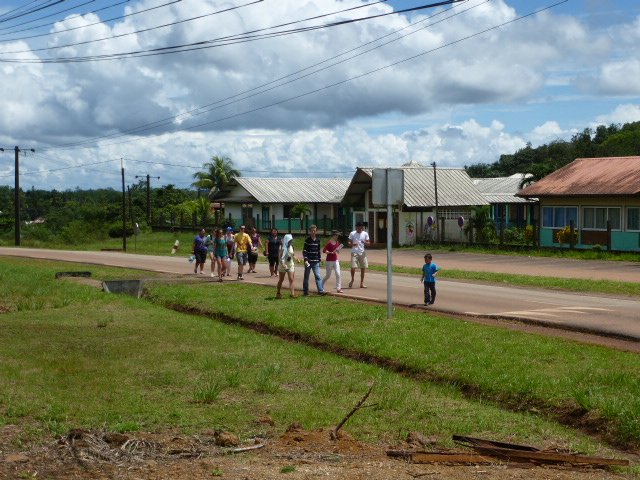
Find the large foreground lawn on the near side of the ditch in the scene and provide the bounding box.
[0,286,612,462]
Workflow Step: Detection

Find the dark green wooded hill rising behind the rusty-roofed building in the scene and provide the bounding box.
[465,122,640,179]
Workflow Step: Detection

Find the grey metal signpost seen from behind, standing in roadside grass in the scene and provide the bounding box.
[371,168,404,320]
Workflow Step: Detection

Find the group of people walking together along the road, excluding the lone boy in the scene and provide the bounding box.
[192,223,380,298]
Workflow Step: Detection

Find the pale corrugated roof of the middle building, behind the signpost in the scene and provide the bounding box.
[346,166,489,208]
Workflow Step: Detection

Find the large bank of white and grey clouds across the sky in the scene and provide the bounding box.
[0,0,640,188]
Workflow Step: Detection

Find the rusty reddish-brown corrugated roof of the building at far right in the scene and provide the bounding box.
[518,157,640,197]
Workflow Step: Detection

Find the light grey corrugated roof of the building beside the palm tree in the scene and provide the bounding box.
[214,177,350,203]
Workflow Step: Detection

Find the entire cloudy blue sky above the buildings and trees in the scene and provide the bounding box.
[0,0,640,190]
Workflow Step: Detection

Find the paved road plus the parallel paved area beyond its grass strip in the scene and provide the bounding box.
[0,248,640,341]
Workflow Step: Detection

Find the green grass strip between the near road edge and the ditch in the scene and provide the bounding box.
[151,284,640,447]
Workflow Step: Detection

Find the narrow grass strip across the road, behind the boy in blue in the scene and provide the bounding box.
[364,264,640,296]
